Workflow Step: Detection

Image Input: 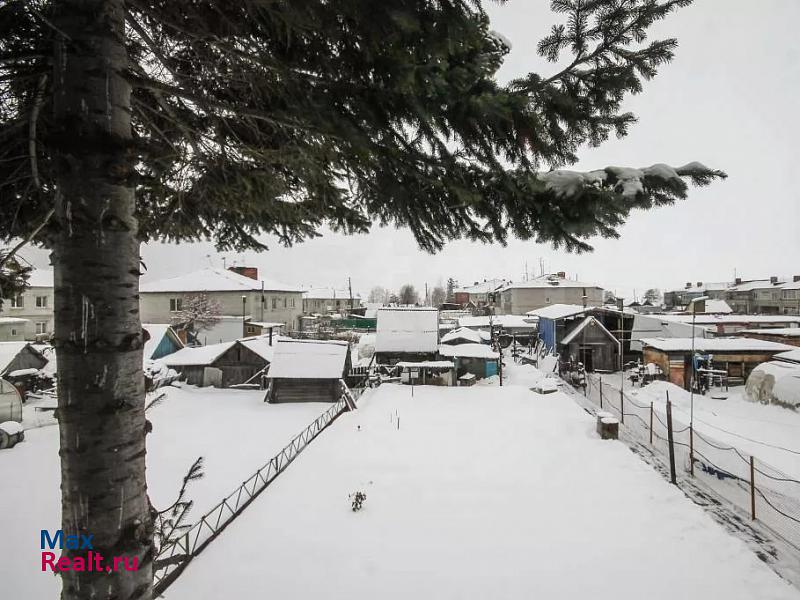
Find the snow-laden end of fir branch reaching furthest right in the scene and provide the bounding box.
[537,162,727,198]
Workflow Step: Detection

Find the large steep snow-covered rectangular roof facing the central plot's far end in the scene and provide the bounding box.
[375,308,439,352]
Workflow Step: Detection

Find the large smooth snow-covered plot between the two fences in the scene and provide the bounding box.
[167,365,800,600]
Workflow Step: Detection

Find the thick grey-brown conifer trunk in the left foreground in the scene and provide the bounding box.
[52,0,153,600]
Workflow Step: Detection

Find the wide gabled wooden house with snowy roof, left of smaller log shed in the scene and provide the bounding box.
[161,337,274,387]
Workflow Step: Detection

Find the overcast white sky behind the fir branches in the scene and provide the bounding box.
[29,0,800,296]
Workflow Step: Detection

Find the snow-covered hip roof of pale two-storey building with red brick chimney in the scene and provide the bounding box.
[139,267,301,293]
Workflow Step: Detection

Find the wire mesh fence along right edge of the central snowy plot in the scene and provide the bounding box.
[586,375,800,551]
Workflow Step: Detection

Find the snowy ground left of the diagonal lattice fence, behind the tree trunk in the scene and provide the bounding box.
[0,386,330,599]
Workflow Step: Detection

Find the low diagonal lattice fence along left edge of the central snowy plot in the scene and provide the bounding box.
[153,388,354,596]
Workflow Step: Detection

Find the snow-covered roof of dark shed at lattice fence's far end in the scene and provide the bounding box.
[267,339,349,379]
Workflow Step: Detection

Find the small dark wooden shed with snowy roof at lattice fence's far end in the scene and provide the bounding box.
[264,339,351,403]
